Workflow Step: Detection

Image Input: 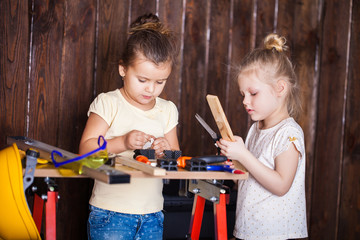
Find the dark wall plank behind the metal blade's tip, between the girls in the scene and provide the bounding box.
[179,0,210,156]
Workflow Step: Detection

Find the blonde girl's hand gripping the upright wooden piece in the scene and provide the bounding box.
[216,136,245,161]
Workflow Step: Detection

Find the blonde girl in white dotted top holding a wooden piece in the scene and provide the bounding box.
[218,34,307,240]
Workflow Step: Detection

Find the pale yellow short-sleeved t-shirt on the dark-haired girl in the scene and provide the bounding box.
[88,89,178,214]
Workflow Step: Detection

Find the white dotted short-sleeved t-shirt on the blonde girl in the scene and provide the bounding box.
[234,118,307,240]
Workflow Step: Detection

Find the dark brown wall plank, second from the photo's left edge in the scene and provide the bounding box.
[29,1,65,146]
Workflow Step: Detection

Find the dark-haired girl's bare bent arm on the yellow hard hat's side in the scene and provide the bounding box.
[79,113,153,154]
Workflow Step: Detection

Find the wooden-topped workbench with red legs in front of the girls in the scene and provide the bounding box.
[8,137,249,240]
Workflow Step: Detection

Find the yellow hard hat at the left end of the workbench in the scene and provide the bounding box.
[0,143,41,239]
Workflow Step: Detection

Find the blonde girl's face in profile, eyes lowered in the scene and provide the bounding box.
[238,69,284,128]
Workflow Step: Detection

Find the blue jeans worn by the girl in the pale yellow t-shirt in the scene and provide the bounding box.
[87,205,164,240]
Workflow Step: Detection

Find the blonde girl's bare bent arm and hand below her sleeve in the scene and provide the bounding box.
[219,137,299,196]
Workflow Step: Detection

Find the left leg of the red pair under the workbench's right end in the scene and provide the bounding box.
[189,195,205,240]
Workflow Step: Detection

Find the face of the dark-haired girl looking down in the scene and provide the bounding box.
[119,54,171,110]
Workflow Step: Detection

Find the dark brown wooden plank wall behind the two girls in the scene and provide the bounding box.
[0,0,360,239]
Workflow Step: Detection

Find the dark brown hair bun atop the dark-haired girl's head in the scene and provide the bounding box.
[129,13,171,36]
